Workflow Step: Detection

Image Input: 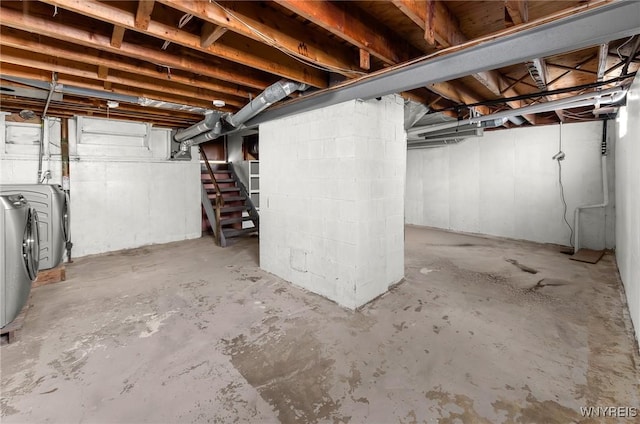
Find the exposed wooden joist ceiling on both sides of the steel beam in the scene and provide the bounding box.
[0,0,640,127]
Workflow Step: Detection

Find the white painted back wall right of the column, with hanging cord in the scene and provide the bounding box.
[406,122,615,249]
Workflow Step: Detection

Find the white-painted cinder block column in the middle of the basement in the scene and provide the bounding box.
[260,95,406,309]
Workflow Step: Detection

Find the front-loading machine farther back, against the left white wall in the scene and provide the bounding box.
[0,184,69,270]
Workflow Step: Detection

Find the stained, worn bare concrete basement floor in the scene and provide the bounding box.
[0,227,640,423]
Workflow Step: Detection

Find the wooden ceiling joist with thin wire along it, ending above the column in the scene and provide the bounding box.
[158,0,358,77]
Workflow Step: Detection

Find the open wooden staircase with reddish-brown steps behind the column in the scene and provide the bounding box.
[200,149,260,247]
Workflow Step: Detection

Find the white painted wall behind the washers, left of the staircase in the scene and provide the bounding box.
[0,114,201,257]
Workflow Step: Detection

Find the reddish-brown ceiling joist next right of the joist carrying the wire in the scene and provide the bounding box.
[276,0,415,65]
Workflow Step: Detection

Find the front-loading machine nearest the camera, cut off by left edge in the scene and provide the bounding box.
[0,194,40,327]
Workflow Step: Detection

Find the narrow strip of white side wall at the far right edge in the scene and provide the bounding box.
[615,77,640,348]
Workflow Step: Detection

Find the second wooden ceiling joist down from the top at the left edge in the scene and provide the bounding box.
[0,27,257,99]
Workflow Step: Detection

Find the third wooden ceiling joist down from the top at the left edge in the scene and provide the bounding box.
[2,47,246,107]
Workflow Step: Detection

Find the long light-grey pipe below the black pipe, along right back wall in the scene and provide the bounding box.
[407,87,626,137]
